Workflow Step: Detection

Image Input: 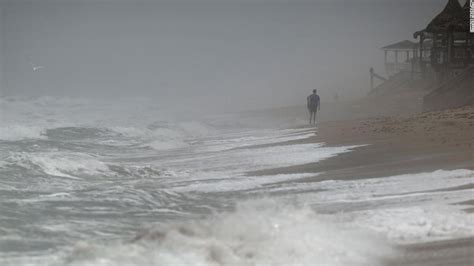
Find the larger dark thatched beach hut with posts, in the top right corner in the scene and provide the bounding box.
[414,0,474,82]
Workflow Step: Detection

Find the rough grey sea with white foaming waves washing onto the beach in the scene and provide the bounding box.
[0,97,474,266]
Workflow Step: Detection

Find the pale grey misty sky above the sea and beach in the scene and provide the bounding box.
[0,0,460,109]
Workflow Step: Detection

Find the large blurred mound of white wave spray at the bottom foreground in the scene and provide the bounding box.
[61,200,393,266]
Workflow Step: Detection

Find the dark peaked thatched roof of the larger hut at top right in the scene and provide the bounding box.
[426,0,462,33]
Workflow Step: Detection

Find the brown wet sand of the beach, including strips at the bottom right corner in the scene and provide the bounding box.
[248,106,474,266]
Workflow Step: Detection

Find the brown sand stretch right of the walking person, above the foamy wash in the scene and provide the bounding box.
[249,106,474,180]
